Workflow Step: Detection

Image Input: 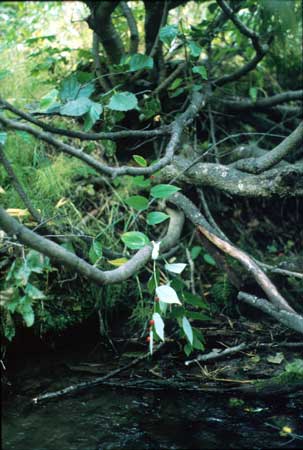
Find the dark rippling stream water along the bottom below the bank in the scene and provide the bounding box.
[2,383,303,450]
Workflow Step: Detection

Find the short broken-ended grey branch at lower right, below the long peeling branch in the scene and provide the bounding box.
[238,292,303,333]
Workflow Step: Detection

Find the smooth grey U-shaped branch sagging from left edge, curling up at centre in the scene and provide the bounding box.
[0,207,184,285]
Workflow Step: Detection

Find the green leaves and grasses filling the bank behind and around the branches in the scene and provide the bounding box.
[0,0,302,355]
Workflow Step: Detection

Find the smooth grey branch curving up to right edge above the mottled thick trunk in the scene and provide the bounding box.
[236,122,303,174]
